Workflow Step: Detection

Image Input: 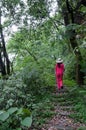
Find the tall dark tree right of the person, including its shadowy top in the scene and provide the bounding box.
[58,0,86,85]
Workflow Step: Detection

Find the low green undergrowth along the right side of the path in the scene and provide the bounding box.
[65,86,86,123]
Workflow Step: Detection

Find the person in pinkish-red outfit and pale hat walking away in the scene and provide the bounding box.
[55,58,65,90]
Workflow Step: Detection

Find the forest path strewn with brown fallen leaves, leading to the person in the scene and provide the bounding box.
[41,87,86,130]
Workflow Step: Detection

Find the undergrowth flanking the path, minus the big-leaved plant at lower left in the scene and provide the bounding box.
[0,75,86,130]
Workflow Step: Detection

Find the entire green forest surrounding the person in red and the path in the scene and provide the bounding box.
[0,0,86,130]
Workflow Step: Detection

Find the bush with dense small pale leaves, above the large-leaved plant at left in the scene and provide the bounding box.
[0,73,35,109]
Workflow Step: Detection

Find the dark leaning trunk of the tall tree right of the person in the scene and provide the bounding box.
[62,0,84,85]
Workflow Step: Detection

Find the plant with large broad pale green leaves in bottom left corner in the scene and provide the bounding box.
[0,107,32,130]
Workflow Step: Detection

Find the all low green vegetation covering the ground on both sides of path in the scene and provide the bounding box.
[0,75,86,130]
